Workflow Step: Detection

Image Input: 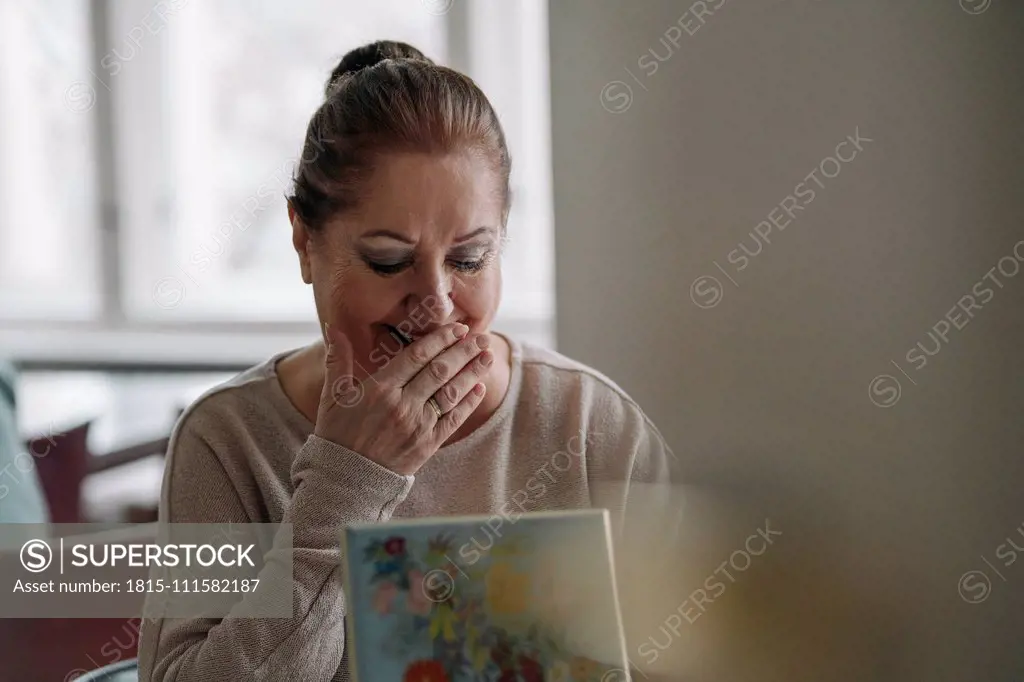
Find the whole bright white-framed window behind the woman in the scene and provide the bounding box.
[0,0,553,367]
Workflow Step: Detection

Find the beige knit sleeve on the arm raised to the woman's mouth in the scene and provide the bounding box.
[139,413,413,682]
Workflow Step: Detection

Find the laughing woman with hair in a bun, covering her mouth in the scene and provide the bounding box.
[139,42,672,681]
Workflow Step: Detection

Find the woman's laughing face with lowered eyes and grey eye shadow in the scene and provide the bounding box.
[292,149,503,379]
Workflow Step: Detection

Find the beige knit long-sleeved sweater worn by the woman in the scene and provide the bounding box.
[139,339,677,682]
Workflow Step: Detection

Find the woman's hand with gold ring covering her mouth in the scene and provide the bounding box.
[313,324,494,475]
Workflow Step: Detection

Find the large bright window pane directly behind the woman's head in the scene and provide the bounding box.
[118,0,445,322]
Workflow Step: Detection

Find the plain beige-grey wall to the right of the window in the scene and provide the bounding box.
[550,0,1024,682]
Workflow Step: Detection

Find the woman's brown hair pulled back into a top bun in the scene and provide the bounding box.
[288,41,512,229]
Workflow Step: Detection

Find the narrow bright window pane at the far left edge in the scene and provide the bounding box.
[0,0,99,318]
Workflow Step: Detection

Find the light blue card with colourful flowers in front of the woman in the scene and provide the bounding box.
[342,510,629,682]
